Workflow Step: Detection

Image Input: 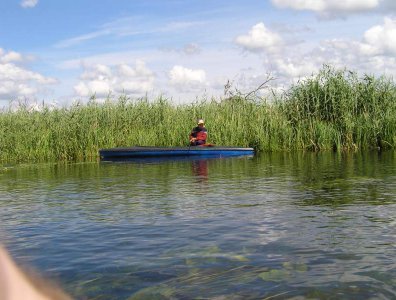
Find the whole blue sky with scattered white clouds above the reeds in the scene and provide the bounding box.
[0,0,396,106]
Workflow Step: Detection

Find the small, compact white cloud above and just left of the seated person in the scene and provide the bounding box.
[169,66,206,91]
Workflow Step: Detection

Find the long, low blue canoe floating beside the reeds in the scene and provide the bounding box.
[99,146,254,160]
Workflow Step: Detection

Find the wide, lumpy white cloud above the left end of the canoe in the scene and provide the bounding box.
[74,60,155,98]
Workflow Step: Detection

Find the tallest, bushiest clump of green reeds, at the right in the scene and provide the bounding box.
[280,66,396,150]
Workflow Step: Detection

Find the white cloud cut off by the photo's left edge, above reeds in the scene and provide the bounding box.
[0,48,57,100]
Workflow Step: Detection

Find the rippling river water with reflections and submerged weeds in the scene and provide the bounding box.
[0,152,396,300]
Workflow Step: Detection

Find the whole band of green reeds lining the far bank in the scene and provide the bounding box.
[0,67,396,161]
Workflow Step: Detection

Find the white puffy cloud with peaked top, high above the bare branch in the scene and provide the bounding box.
[235,23,283,52]
